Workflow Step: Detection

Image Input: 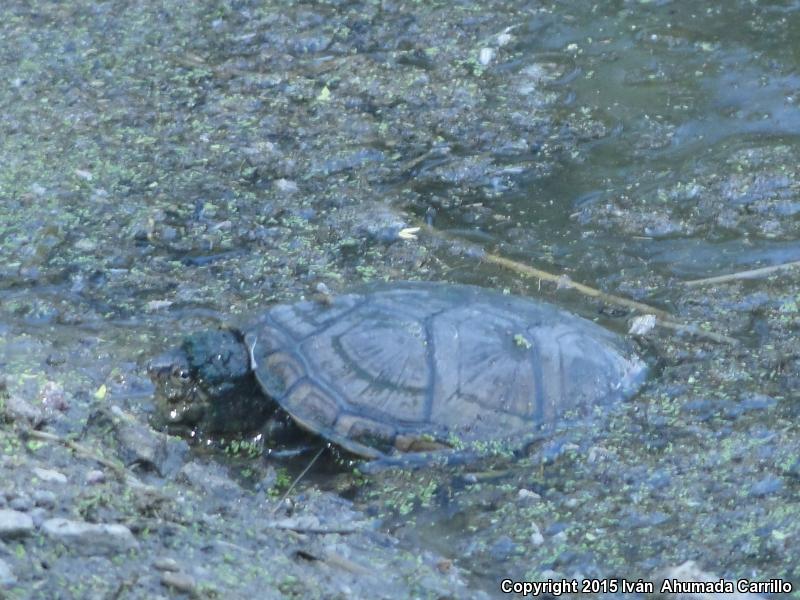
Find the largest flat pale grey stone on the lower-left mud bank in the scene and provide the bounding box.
[42,519,139,556]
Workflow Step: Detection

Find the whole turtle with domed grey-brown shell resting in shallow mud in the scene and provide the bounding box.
[149,282,647,459]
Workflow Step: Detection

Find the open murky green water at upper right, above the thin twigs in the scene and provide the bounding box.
[438,2,800,292]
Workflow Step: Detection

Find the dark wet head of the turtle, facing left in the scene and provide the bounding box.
[147,329,274,434]
